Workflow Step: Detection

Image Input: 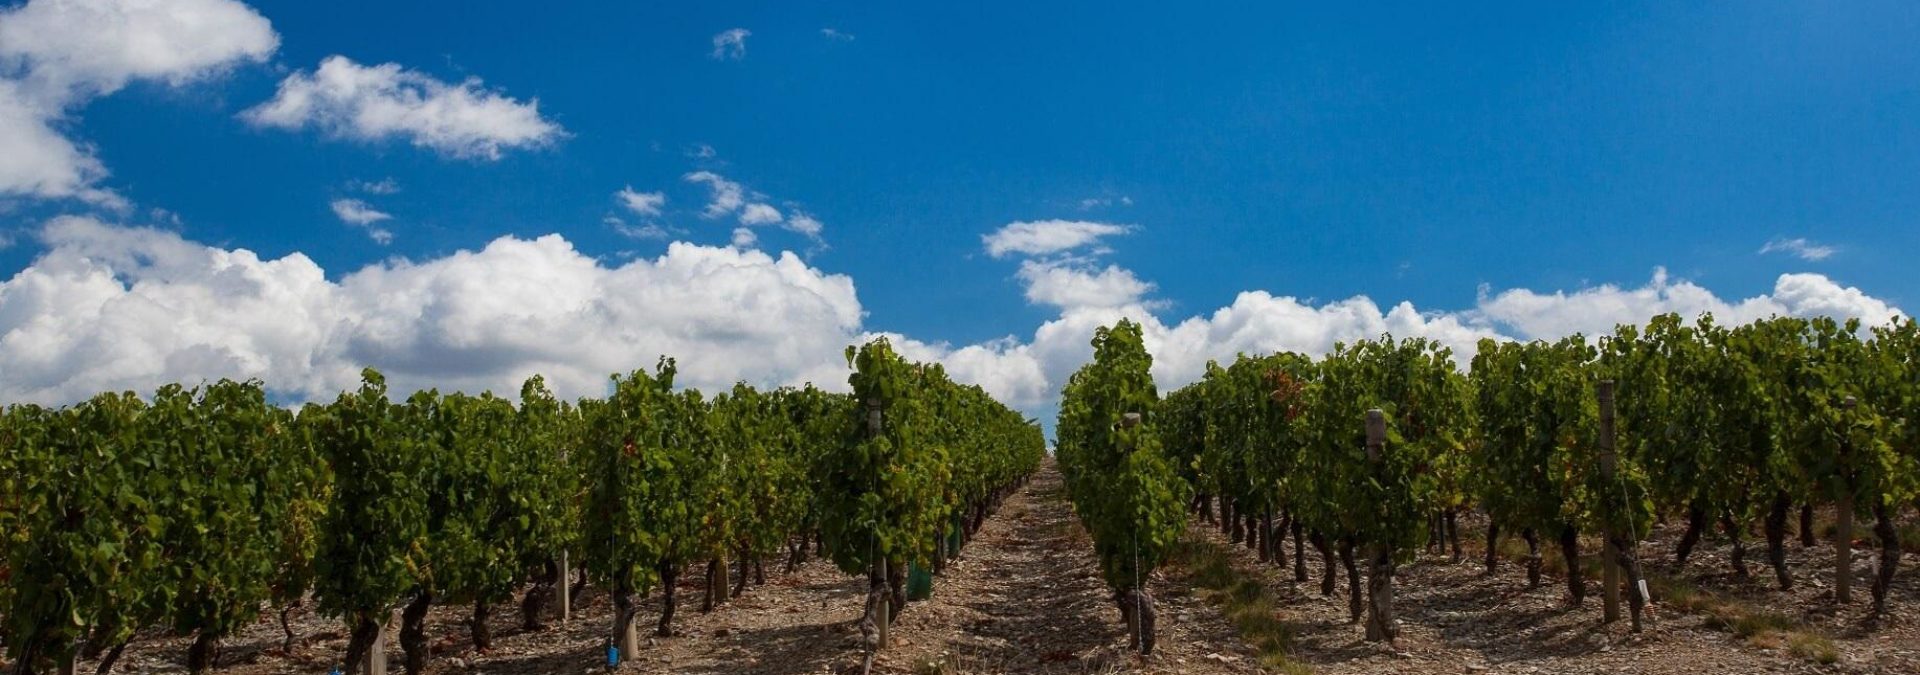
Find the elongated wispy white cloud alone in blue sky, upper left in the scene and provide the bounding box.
[242,56,566,159]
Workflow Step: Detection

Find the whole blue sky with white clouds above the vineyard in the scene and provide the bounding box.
[0,0,1920,410]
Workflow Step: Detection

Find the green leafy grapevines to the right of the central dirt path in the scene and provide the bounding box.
[1105,314,1920,640]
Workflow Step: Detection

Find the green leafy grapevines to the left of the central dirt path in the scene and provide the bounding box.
[0,341,1044,673]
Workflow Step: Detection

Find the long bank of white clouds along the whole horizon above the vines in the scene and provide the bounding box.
[0,217,1899,433]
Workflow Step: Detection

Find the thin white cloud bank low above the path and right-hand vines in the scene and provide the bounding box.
[902,261,1903,418]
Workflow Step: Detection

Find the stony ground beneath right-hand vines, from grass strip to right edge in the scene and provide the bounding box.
[1196,510,1920,675]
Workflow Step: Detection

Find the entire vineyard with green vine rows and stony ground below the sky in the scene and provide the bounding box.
[0,314,1920,675]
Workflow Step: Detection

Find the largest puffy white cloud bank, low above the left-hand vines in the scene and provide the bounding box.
[0,217,862,403]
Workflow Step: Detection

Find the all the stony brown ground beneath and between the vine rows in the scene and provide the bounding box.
[41,466,1920,675]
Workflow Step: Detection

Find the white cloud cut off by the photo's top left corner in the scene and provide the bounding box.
[0,0,280,209]
